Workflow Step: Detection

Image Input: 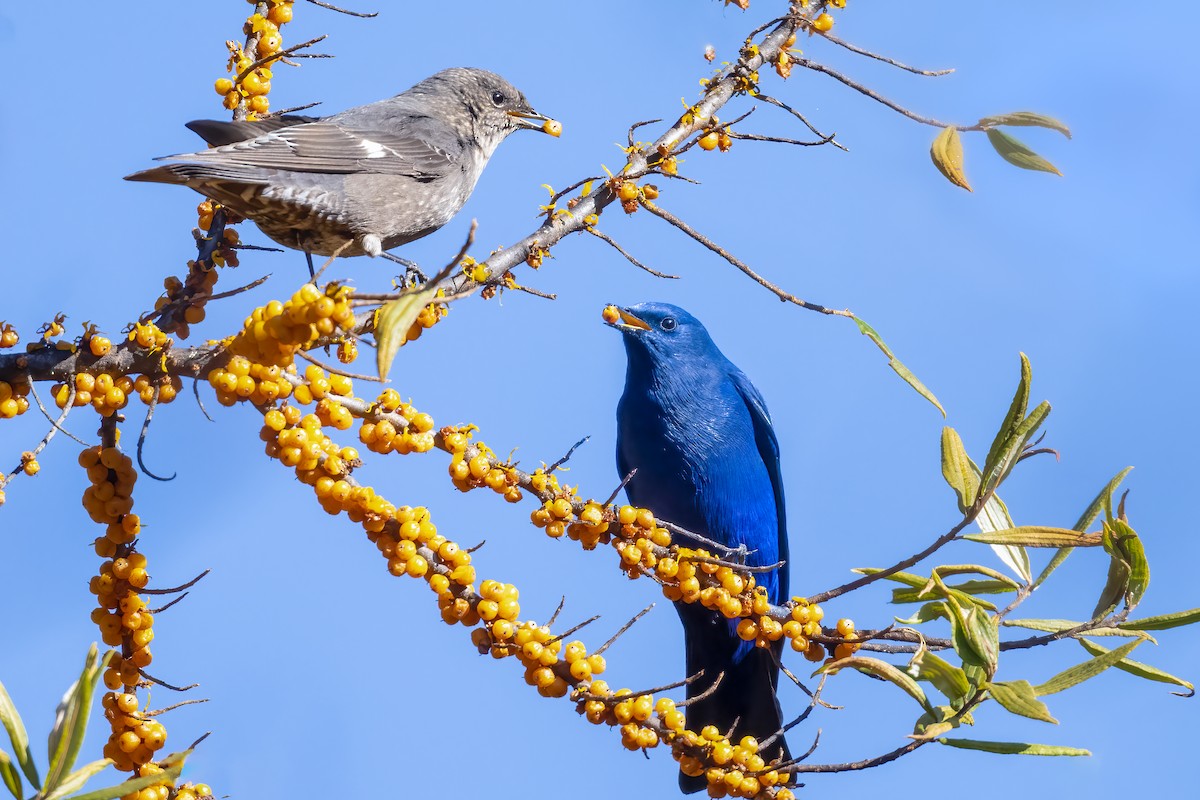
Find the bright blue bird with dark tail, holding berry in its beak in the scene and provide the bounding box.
[610,302,791,794]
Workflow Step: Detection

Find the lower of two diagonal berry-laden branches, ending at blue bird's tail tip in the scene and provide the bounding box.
[247,400,811,800]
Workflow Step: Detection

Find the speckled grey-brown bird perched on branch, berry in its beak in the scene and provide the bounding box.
[125,67,560,270]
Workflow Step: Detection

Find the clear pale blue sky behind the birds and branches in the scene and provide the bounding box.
[0,0,1200,800]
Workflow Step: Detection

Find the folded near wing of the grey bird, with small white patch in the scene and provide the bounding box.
[159,121,460,180]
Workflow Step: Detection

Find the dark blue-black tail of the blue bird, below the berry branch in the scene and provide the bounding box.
[676,603,792,794]
